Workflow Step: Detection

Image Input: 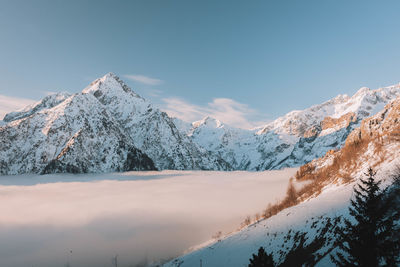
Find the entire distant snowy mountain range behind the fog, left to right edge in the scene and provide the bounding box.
[0,73,400,175]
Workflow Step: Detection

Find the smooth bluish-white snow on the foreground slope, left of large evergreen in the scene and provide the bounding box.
[164,182,352,267]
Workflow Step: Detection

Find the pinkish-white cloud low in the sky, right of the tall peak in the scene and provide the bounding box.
[163,97,267,129]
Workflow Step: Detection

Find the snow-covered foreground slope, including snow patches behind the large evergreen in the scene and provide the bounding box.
[163,162,400,267]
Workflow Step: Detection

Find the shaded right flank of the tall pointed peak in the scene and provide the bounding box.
[83,73,229,170]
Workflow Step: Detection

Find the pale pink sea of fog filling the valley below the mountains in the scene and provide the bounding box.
[0,169,297,267]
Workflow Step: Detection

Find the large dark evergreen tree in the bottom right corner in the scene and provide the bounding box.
[331,168,400,267]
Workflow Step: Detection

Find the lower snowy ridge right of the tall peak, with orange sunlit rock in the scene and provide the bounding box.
[180,85,400,171]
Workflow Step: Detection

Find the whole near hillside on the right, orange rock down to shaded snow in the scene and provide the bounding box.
[164,91,400,267]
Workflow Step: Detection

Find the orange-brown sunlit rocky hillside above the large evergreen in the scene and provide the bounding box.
[297,95,400,187]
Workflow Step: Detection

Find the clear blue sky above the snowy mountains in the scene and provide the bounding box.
[0,0,400,125]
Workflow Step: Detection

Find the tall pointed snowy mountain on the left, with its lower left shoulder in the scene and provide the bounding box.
[0,73,229,174]
